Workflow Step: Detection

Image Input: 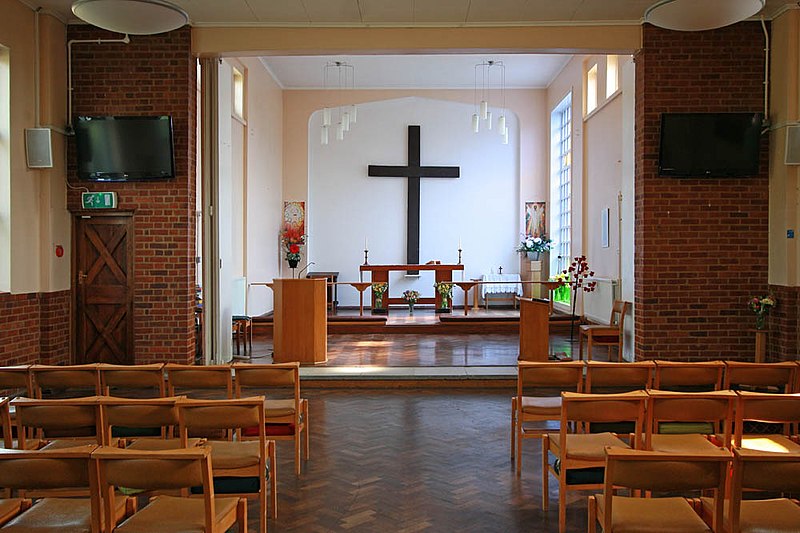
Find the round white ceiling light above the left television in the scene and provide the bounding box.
[72,0,189,35]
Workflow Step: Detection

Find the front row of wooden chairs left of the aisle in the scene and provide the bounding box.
[0,363,310,476]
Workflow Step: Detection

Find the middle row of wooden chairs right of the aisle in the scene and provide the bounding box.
[542,390,800,532]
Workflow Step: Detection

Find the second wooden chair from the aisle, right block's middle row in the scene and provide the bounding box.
[645,390,736,454]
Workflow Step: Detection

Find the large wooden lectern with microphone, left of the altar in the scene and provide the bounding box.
[272,278,328,364]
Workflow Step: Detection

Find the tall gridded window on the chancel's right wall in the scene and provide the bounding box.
[550,93,572,296]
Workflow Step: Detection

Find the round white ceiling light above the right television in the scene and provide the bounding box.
[644,0,765,31]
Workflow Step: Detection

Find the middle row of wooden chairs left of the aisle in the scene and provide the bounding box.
[0,396,277,533]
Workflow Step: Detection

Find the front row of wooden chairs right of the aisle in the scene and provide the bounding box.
[511,361,800,475]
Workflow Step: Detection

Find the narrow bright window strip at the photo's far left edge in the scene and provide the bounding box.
[0,45,11,292]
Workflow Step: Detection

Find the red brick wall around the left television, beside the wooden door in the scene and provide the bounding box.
[67,25,197,363]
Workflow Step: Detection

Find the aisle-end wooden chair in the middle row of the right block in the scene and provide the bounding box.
[542,391,647,533]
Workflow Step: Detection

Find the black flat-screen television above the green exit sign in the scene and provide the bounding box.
[74,116,175,181]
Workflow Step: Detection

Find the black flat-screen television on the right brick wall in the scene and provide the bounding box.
[658,113,763,177]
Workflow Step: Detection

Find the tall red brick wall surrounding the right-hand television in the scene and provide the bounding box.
[634,22,769,360]
